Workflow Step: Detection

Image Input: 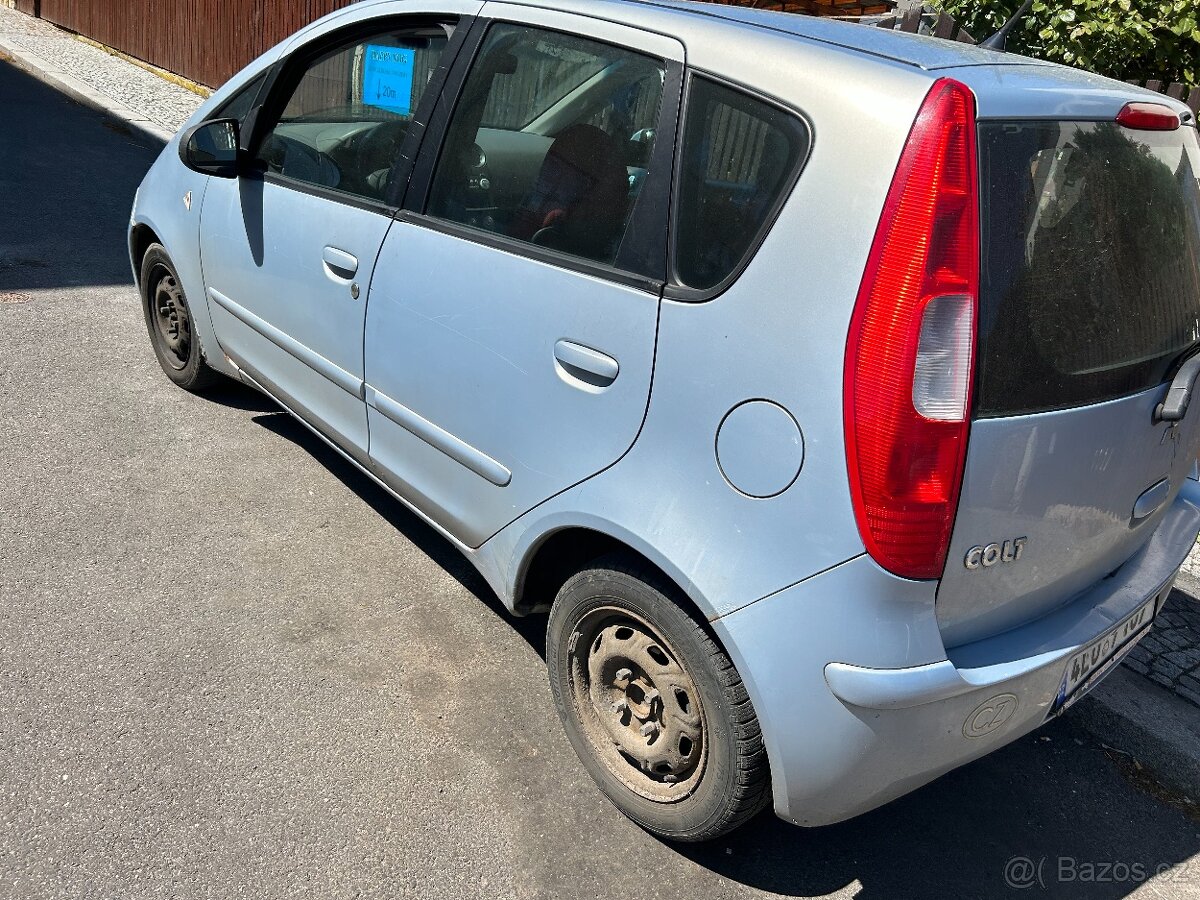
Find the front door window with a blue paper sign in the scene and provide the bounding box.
[258,25,450,200]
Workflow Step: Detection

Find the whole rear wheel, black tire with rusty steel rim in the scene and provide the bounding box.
[546,554,770,841]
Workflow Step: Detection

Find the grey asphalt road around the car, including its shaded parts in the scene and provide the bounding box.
[0,58,1200,900]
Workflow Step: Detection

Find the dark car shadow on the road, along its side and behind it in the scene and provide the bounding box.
[248,401,1200,900]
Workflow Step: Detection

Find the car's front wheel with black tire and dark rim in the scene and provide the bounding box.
[138,244,221,391]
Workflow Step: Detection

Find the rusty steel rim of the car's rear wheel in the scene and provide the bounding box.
[568,606,708,803]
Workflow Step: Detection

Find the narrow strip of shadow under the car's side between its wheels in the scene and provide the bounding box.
[253,412,546,660]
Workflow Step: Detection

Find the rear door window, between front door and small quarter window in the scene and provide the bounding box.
[426,24,665,265]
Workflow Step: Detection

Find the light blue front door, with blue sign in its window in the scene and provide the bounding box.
[200,18,452,460]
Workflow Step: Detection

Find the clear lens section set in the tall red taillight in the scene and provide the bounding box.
[912,294,974,422]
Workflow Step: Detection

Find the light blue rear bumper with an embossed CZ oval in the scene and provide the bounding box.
[714,481,1200,826]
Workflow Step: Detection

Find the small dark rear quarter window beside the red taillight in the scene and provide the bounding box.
[674,76,809,290]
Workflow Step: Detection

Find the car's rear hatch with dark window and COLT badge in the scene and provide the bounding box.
[937,111,1200,647]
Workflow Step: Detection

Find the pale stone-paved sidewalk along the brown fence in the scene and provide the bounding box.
[0,6,203,140]
